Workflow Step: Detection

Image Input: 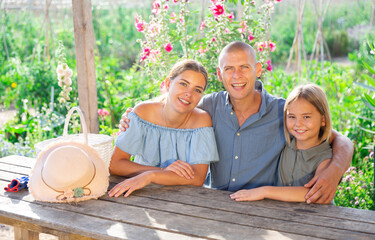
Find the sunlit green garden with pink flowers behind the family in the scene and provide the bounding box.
[0,0,375,210]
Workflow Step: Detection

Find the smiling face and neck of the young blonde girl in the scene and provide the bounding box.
[286,98,325,149]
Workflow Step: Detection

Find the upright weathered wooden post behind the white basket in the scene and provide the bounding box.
[72,0,99,133]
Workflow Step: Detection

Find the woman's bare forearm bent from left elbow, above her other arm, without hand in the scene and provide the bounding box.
[109,146,161,177]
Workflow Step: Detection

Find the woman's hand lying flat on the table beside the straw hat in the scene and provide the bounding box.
[108,171,151,197]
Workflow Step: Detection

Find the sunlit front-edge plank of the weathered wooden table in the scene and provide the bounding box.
[0,196,203,240]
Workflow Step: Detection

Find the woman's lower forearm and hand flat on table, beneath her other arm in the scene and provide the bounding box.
[108,164,208,197]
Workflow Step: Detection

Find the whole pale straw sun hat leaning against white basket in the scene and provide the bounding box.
[29,142,109,202]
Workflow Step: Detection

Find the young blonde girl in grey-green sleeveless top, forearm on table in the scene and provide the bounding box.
[230,84,332,202]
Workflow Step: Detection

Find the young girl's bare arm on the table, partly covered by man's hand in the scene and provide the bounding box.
[230,159,331,202]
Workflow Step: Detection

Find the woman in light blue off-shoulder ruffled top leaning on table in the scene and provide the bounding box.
[108,60,219,197]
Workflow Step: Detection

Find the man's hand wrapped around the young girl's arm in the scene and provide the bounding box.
[304,163,341,204]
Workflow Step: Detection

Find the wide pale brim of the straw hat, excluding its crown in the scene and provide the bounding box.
[29,142,109,203]
